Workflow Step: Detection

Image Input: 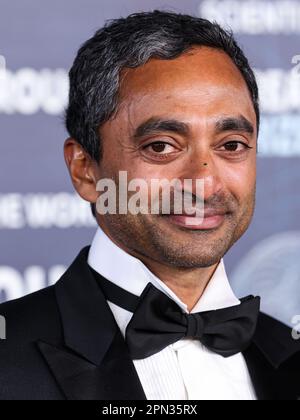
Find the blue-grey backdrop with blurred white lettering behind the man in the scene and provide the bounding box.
[0,0,300,324]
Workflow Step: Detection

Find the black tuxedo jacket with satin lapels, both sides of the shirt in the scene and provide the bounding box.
[0,248,300,400]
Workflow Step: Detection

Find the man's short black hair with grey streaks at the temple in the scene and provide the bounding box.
[65,10,260,162]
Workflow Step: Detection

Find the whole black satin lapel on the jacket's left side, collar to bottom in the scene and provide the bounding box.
[38,248,146,400]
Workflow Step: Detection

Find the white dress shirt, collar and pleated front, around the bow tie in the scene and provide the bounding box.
[88,228,256,400]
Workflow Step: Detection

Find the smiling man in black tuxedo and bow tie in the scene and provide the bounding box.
[0,11,300,400]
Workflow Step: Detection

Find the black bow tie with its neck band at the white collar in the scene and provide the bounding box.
[92,270,260,360]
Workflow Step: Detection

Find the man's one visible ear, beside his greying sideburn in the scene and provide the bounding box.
[64,138,99,203]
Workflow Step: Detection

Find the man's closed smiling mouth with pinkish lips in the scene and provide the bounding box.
[164,209,229,230]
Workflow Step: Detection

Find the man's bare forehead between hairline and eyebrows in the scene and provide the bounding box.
[115,47,255,126]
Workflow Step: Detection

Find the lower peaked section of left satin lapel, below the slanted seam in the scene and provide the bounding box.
[38,334,146,400]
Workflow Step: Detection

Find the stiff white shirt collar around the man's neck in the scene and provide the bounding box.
[88,227,240,313]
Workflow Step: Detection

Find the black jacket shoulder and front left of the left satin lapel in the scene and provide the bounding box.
[0,286,62,400]
